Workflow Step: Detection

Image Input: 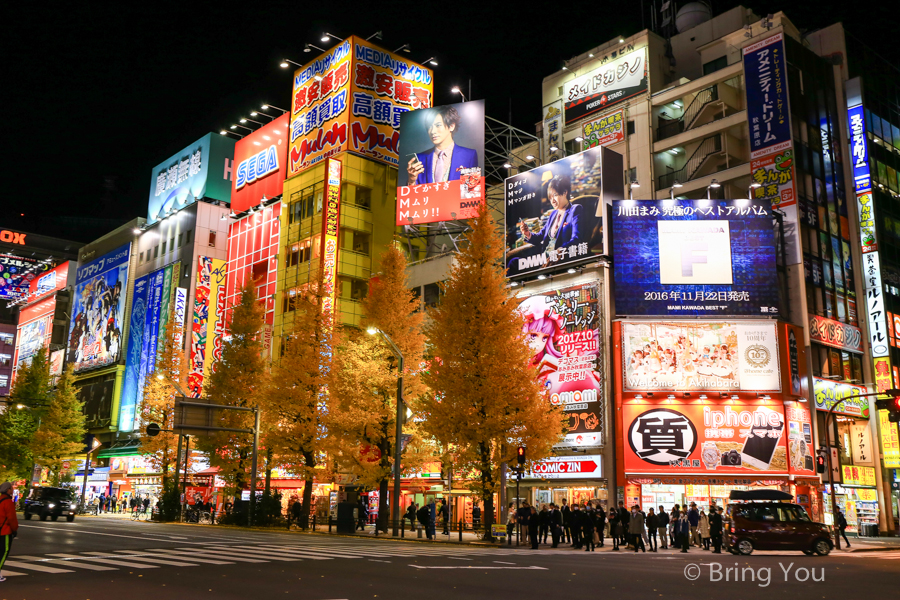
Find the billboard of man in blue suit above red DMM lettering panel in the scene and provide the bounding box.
[396,100,485,225]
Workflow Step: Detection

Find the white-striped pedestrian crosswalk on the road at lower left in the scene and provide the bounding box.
[2,541,516,577]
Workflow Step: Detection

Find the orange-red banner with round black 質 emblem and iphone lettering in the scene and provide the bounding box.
[622,401,788,474]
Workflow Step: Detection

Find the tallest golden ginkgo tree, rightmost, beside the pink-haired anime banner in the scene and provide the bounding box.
[417,206,565,538]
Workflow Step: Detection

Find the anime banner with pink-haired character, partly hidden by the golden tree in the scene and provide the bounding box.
[519,284,603,446]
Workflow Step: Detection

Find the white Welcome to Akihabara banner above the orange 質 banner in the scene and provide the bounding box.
[622,321,781,392]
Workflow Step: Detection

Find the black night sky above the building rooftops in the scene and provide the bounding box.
[0,0,898,241]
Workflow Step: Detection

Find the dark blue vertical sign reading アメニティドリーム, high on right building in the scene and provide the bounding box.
[744,33,791,158]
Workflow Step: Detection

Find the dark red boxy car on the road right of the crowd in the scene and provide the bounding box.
[723,490,834,556]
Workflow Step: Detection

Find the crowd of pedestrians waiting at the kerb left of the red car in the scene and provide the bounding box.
[506,500,723,554]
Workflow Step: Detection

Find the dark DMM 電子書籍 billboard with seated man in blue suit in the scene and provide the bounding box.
[504,148,622,277]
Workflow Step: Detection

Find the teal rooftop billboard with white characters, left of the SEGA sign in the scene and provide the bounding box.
[147,133,234,225]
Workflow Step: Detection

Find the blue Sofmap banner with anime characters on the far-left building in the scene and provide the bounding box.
[68,243,131,373]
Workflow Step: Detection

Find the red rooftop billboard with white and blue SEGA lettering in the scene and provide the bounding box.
[231,113,291,213]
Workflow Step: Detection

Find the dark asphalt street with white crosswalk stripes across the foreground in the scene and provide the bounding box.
[0,517,900,600]
